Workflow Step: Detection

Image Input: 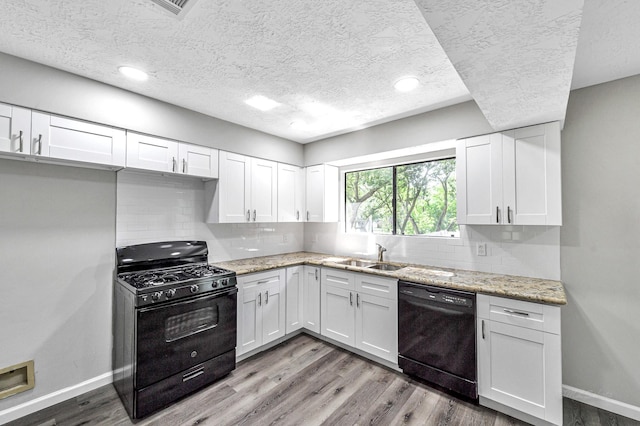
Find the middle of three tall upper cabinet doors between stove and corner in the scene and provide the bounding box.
[251,158,278,222]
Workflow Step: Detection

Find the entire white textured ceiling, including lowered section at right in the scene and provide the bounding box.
[0,0,640,142]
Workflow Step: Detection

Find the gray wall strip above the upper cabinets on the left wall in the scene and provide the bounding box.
[0,53,303,165]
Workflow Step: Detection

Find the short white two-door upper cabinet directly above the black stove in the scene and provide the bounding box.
[127,132,218,178]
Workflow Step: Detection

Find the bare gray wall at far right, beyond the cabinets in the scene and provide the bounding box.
[560,76,640,407]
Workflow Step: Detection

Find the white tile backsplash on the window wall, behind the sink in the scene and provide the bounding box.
[304,223,560,280]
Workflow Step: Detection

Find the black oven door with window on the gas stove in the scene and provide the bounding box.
[135,287,238,389]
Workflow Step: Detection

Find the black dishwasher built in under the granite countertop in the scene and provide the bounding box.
[398,280,478,400]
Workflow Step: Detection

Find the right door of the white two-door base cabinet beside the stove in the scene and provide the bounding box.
[259,269,286,345]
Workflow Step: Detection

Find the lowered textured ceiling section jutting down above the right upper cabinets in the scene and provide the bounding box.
[416,0,583,130]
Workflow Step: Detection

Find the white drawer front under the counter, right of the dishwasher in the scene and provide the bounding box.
[476,294,560,334]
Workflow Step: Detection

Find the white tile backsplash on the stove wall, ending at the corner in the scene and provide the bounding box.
[116,171,304,262]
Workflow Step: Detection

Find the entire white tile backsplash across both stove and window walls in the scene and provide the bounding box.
[116,171,560,279]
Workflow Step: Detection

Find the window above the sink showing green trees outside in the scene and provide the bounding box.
[345,158,459,237]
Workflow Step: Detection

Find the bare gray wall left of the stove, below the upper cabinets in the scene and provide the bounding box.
[0,159,116,412]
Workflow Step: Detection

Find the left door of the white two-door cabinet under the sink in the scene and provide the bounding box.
[320,282,356,346]
